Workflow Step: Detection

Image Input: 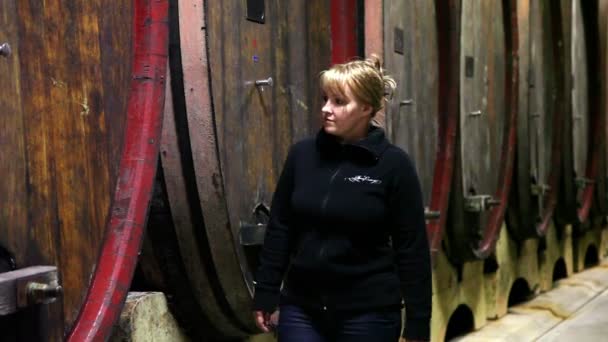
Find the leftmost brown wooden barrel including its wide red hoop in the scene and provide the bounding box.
[0,0,167,341]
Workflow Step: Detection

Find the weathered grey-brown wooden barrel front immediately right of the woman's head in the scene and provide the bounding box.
[384,0,436,209]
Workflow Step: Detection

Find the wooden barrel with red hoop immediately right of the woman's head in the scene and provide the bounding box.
[384,0,457,254]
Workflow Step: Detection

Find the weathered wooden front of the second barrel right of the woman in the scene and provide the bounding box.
[459,0,506,208]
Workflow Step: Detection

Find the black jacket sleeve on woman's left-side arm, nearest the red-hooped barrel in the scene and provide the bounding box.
[253,146,295,312]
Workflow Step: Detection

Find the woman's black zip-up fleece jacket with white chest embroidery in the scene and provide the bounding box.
[254,127,432,339]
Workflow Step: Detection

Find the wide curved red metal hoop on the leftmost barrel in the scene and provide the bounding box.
[68,0,169,341]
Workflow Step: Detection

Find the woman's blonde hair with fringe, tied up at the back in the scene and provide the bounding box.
[320,55,397,124]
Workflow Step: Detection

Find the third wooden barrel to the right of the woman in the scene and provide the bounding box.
[508,0,564,241]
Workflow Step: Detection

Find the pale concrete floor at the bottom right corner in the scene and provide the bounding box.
[453,261,608,342]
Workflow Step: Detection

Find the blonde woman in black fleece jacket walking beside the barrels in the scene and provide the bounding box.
[254,58,431,342]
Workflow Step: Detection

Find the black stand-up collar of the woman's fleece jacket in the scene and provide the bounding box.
[316,126,389,160]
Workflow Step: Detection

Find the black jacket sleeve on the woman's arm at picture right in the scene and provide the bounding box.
[389,156,432,340]
